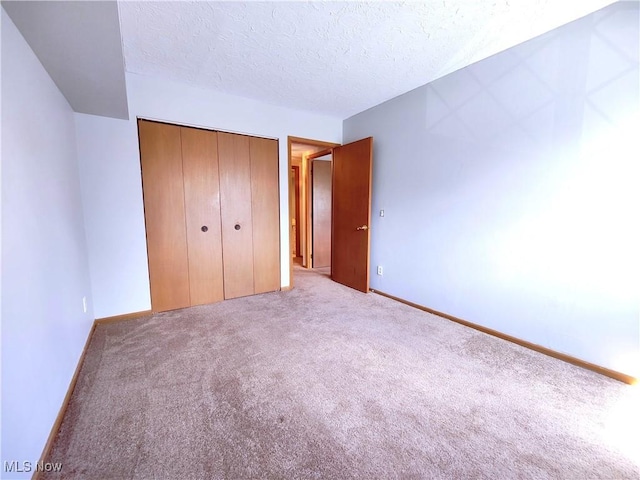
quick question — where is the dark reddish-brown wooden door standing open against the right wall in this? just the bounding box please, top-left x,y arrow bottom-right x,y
331,137 -> 373,292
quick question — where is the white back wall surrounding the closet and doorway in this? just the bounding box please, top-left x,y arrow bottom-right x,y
76,74 -> 342,318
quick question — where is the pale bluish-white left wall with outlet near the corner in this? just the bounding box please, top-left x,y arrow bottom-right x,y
0,9 -> 93,478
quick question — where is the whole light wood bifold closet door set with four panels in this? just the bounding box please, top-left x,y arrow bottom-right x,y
138,120 -> 280,312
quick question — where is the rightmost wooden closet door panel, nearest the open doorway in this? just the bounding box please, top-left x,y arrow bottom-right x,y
249,137 -> 280,293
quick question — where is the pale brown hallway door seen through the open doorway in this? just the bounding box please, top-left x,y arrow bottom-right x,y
311,160 -> 331,268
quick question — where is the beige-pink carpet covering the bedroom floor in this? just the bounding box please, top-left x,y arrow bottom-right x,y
45,270 -> 640,479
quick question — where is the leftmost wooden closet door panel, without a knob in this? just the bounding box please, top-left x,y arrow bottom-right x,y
138,120 -> 190,312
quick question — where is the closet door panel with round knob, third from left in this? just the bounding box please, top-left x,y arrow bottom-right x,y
218,132 -> 254,299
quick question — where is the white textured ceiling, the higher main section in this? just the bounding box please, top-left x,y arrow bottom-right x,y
119,0 -> 614,118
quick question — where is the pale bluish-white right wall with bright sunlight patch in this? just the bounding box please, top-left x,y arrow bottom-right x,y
344,2 -> 640,376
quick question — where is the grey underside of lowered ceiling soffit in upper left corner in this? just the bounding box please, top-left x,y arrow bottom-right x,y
2,0 -> 129,119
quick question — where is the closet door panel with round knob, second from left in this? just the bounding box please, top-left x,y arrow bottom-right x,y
180,127 -> 224,305
